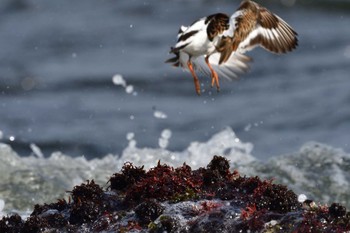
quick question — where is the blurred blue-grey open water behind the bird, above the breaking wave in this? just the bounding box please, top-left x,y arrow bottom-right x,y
0,0 -> 350,160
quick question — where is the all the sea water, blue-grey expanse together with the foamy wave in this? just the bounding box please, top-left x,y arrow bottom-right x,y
0,0 -> 350,215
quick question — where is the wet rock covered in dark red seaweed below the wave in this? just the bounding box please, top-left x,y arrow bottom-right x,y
0,156 -> 350,232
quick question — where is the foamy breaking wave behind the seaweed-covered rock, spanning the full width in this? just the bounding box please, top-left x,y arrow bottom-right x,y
0,128 -> 350,216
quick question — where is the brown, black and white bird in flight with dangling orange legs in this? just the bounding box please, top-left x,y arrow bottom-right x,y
166,0 -> 298,95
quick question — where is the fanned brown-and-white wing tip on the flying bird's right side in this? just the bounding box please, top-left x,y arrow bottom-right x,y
237,7 -> 298,53
